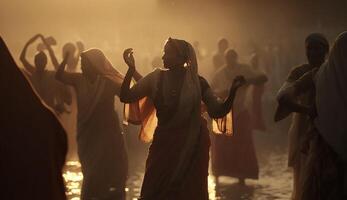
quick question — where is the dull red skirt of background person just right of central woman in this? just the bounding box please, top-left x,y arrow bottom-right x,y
211,111 -> 259,179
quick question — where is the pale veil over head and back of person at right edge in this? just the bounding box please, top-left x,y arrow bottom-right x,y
315,32 -> 347,160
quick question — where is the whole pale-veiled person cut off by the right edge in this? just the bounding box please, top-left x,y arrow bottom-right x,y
312,32 -> 347,200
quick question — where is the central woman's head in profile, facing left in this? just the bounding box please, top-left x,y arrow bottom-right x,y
162,38 -> 189,69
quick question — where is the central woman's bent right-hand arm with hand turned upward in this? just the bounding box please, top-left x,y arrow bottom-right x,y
203,76 -> 245,118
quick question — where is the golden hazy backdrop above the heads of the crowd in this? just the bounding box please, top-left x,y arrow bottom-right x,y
0,0 -> 347,76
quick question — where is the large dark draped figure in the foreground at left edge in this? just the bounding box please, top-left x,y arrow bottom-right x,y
0,38 -> 67,200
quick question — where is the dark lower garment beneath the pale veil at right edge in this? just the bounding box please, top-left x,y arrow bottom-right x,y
296,127 -> 345,200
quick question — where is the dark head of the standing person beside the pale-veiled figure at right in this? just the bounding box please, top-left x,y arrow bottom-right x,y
305,33 -> 329,67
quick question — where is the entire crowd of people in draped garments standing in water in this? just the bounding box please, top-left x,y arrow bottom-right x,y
0,32 -> 347,200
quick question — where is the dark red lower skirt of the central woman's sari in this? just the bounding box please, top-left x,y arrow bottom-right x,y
140,118 -> 210,200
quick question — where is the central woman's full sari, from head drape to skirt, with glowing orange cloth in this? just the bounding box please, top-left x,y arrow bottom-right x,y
125,39 -> 209,200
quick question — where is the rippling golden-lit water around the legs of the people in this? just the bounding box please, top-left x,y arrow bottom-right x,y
63,153 -> 293,200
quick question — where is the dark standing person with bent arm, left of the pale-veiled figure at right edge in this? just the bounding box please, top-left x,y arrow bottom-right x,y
275,33 -> 329,199
